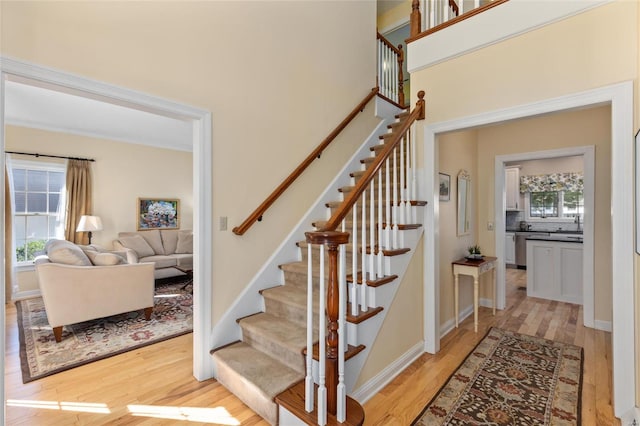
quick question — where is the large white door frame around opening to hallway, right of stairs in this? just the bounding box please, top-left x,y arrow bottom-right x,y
423,81 -> 637,417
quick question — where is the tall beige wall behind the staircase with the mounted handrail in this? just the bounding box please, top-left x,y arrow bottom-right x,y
0,1 -> 376,323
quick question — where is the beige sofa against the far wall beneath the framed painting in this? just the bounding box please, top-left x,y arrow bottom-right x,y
113,229 -> 193,279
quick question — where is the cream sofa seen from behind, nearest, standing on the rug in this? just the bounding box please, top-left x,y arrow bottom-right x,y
35,240 -> 155,342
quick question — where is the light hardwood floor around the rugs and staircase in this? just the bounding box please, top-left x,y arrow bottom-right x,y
5,270 -> 620,426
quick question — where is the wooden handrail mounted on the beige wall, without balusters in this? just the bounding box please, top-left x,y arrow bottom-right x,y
233,87 -> 378,235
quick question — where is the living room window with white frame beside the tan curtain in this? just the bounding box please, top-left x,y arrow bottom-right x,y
11,160 -> 66,265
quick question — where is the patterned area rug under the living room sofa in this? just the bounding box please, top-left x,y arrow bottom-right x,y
16,279 -> 193,383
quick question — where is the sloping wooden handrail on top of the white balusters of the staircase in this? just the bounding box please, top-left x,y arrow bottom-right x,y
321,90 -> 425,232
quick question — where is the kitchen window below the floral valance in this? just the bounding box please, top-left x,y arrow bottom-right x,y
525,191 -> 584,220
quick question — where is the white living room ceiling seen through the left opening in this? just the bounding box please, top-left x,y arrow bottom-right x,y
5,80 -> 193,151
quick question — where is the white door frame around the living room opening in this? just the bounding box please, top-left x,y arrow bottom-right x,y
0,56 -> 213,423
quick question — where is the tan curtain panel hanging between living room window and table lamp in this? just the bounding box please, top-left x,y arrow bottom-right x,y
65,160 -> 91,244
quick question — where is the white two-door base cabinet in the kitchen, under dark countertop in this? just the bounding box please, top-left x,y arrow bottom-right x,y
527,240 -> 582,305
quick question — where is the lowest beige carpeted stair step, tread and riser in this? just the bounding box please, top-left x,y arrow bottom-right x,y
212,342 -> 304,424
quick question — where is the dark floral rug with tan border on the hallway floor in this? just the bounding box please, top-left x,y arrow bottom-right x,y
412,328 -> 583,426
